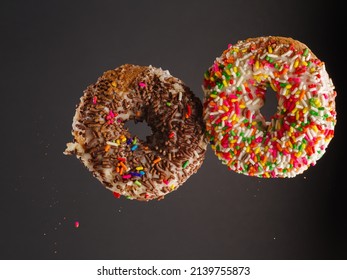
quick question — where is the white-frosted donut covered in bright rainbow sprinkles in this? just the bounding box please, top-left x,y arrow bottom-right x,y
202,36 -> 336,178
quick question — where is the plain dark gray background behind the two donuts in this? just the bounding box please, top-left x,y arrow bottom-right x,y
0,0 -> 347,259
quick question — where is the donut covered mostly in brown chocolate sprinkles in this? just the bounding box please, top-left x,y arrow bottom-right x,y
64,64 -> 207,201
